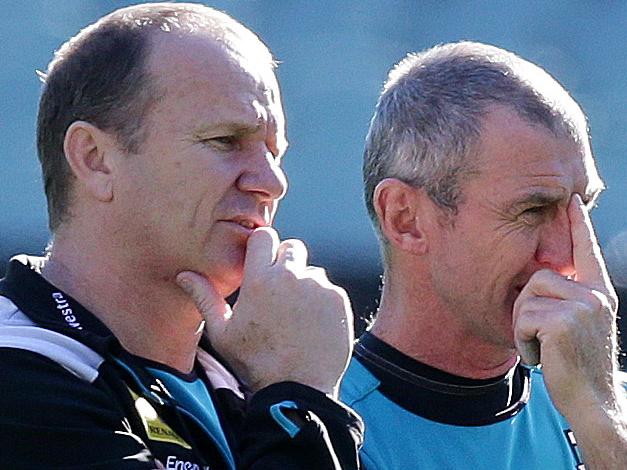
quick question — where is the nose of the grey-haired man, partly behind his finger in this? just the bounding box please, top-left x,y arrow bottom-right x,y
536,208 -> 575,276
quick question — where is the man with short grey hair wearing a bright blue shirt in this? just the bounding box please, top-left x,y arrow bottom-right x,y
341,42 -> 627,470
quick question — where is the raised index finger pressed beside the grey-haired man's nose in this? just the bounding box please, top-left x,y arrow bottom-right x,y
568,194 -> 609,287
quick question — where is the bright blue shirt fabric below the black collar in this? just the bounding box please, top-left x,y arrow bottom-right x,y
340,359 -> 578,470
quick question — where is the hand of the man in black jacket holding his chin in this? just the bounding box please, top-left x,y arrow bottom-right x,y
177,227 -> 353,395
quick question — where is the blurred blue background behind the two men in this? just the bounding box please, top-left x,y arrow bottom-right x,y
0,0 -> 627,360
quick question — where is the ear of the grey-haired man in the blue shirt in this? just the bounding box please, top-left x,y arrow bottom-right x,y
372,178 -> 428,255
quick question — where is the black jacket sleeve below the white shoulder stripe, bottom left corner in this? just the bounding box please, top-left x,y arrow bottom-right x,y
0,348 -> 156,470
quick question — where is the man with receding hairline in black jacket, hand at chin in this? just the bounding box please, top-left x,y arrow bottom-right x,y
0,3 -> 362,470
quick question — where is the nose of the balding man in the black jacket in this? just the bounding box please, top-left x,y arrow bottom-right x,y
238,150 -> 287,201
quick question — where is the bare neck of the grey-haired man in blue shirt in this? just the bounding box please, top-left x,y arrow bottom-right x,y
371,268 -> 517,379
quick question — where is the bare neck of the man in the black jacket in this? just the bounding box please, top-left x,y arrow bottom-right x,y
42,229 -> 204,373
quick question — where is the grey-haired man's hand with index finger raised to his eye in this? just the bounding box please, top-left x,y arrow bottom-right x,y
513,194 -> 618,414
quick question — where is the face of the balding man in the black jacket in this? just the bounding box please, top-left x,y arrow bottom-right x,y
116,34 -> 287,295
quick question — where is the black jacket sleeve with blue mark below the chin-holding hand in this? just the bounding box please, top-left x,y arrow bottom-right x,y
238,382 -> 363,470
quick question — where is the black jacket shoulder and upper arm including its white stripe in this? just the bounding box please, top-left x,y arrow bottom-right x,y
0,302 -> 155,469
